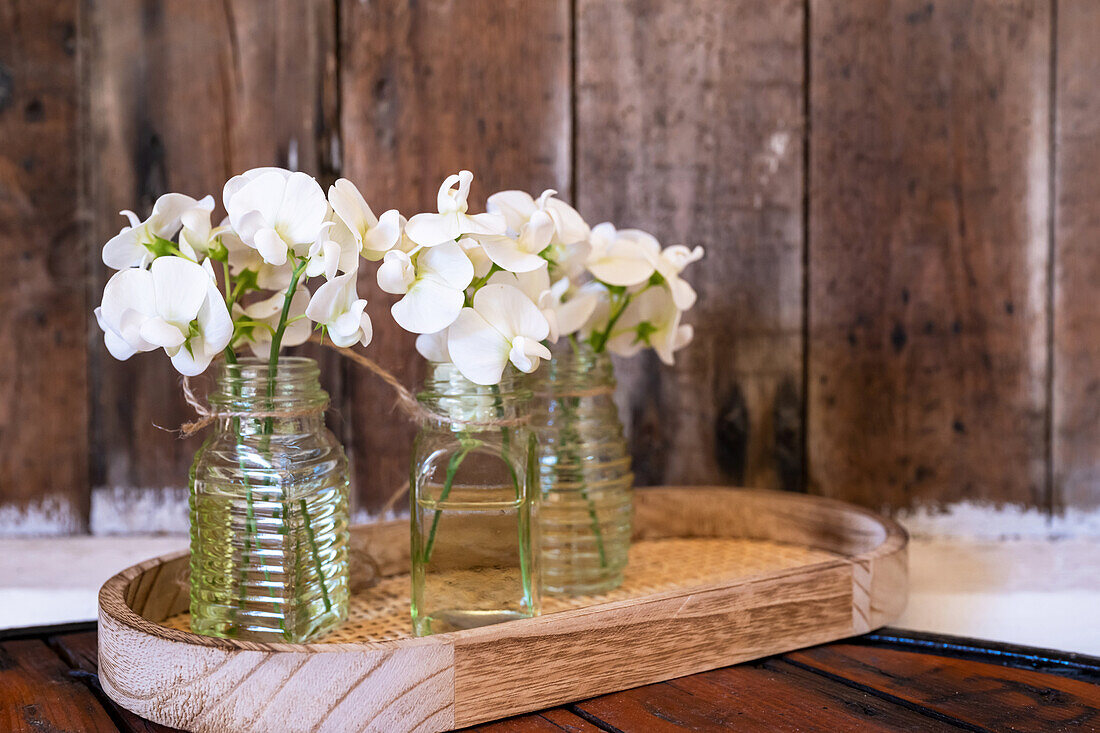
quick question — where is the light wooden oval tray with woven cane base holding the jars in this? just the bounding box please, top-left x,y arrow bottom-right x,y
99,488 -> 908,732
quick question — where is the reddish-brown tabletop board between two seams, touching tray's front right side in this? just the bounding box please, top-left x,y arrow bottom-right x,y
576,659 -> 939,733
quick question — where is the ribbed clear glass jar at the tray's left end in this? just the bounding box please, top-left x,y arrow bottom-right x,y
190,357 -> 349,643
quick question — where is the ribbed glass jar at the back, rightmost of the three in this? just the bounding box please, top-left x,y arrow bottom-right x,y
531,343 -> 634,595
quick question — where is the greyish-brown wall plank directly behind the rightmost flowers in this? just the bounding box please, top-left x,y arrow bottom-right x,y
576,0 -> 804,490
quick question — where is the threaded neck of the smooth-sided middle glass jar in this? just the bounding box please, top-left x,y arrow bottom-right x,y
417,363 -> 531,430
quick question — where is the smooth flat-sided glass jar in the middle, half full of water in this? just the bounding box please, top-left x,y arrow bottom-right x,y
409,364 -> 540,636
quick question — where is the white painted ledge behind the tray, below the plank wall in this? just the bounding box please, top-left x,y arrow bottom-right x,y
0,535 -> 1100,656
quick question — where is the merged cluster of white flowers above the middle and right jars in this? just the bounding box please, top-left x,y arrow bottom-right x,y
378,171 -> 703,384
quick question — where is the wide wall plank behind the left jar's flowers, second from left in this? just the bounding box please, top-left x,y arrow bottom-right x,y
83,0 -> 347,510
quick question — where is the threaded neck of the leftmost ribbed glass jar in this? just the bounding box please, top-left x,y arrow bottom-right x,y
209,357 -> 329,430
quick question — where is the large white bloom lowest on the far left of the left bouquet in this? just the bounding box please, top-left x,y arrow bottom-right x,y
96,256 -> 233,376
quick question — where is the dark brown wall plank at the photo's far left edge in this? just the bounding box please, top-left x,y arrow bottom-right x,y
0,0 -> 89,534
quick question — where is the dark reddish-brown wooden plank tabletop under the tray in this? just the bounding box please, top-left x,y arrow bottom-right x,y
0,623 -> 1100,733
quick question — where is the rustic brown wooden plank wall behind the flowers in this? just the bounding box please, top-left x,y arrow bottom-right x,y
0,0 -> 1100,534
